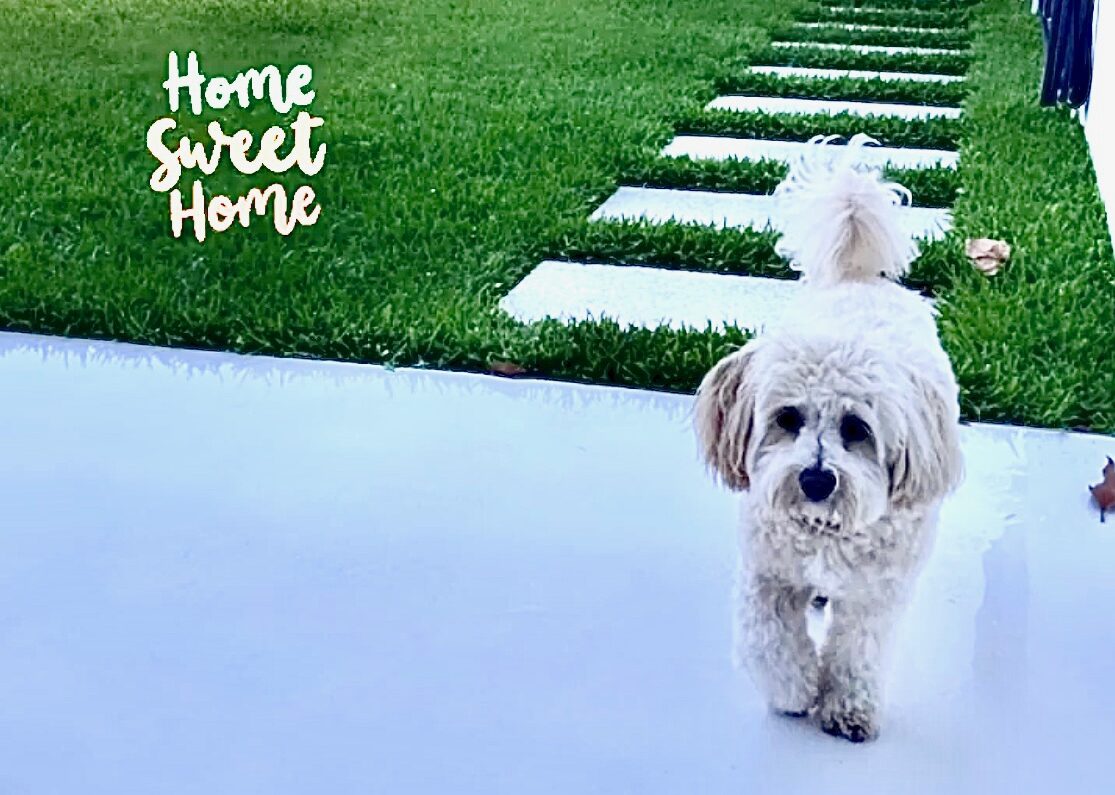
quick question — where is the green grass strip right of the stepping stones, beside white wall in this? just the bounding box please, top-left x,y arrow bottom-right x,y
940,0 -> 1115,433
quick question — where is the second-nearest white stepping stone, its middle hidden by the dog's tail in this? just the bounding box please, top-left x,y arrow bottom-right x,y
589,187 -> 951,240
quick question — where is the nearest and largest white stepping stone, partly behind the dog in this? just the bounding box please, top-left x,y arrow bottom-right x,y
500,260 -> 801,331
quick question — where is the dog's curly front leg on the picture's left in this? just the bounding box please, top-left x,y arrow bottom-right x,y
736,572 -> 820,717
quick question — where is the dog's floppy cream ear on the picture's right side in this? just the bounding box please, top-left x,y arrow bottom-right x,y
890,372 -> 963,505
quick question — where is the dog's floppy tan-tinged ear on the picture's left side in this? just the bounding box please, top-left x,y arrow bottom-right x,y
694,341 -> 756,491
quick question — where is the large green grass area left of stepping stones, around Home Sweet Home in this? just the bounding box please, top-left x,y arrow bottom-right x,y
0,0 -> 799,372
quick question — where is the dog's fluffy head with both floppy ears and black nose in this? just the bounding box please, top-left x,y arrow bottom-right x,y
696,335 -> 961,535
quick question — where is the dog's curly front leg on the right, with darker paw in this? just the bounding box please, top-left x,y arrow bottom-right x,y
818,599 -> 896,743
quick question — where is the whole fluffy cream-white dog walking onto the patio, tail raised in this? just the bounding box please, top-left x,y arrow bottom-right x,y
696,136 -> 962,743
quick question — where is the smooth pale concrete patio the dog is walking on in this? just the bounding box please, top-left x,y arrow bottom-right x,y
0,335 -> 1115,795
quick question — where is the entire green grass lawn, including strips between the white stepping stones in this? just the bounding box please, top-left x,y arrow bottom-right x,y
0,0 -> 1115,432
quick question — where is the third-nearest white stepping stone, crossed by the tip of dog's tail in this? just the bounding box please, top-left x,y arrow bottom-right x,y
662,135 -> 959,168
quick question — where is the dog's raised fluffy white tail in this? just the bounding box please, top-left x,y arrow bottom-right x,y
774,134 -> 918,284
